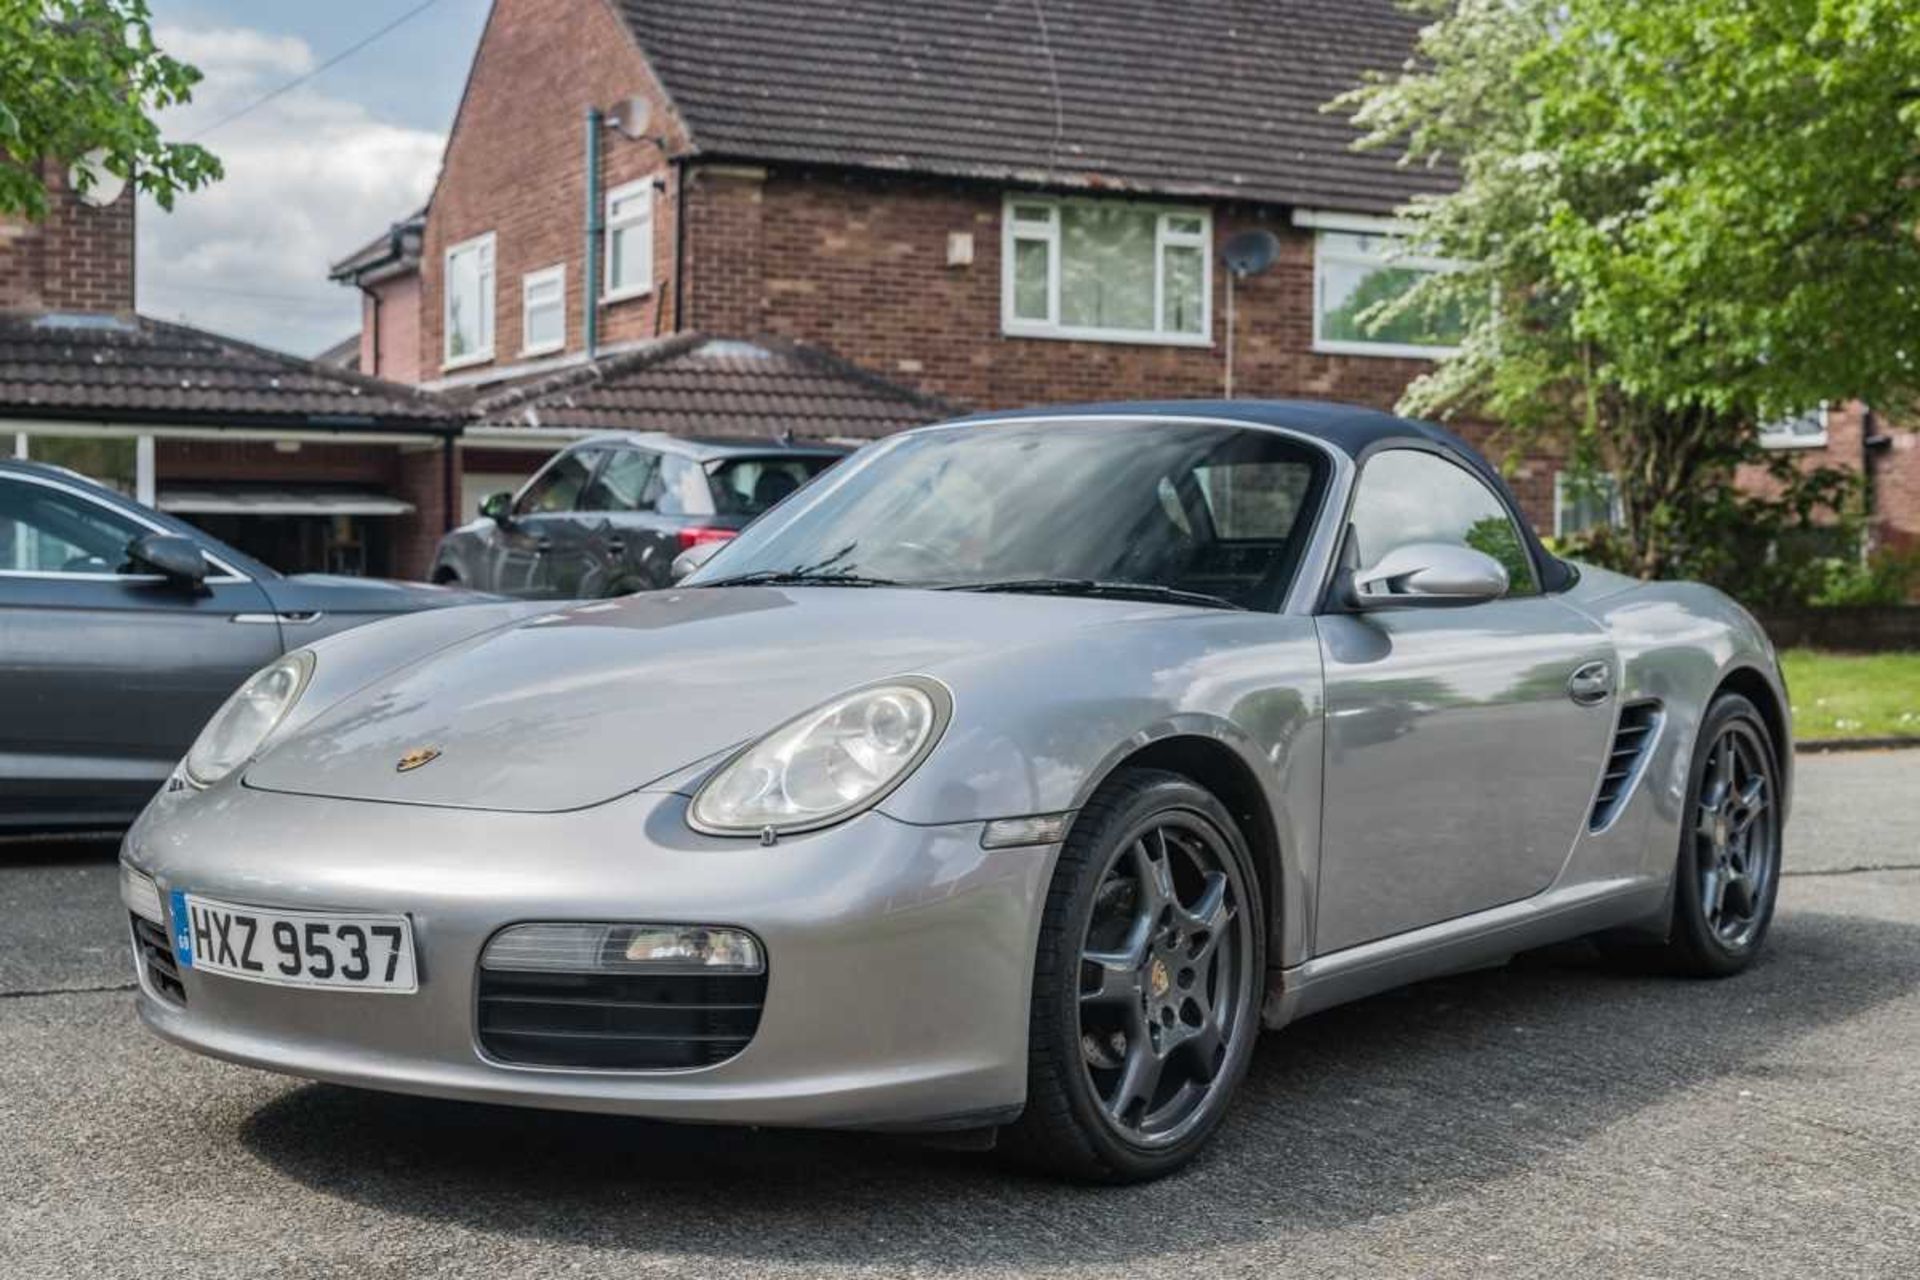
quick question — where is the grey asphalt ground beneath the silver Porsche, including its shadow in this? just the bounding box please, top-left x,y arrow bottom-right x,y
0,752 -> 1920,1280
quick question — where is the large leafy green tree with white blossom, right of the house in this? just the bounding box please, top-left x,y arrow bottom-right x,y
1331,0 -> 1920,576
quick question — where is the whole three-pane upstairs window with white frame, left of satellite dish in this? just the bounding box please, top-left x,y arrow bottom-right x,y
1000,198 -> 1213,345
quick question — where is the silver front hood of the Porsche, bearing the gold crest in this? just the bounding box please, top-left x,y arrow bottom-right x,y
246,587 -> 1192,812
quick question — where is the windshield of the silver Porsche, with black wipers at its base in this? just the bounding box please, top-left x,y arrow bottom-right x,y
687,420 -> 1323,608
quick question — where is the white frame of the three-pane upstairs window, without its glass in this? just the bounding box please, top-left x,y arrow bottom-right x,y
1000,196 -> 1213,347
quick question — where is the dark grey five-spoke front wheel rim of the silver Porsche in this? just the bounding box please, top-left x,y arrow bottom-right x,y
1079,812 -> 1256,1146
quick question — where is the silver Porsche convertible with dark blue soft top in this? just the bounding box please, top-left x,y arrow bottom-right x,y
121,401 -> 1791,1180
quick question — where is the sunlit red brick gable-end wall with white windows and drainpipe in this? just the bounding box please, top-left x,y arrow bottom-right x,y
419,0 -> 684,380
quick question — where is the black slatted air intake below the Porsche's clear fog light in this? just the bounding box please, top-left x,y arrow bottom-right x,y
478,969 -> 766,1071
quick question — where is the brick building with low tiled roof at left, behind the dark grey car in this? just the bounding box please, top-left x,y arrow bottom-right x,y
0,167 -> 463,574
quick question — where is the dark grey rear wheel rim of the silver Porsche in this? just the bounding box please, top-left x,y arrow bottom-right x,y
1693,722 -> 1780,950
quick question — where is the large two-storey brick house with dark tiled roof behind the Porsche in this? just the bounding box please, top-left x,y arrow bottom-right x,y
336,0 -> 1920,560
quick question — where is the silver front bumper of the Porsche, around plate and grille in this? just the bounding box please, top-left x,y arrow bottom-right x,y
123,783 -> 1056,1126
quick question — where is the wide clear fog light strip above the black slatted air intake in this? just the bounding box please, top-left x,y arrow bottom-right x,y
480,923 -> 766,973
